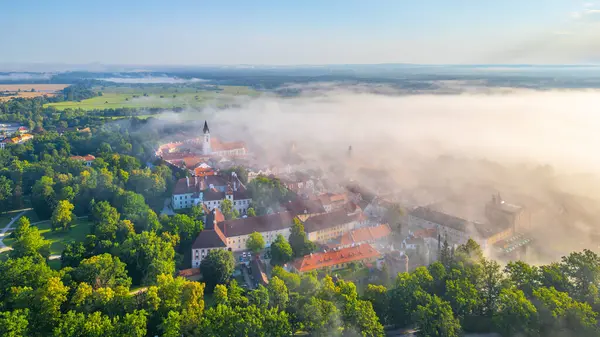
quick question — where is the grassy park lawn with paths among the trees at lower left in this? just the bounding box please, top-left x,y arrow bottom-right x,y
4,218 -> 91,255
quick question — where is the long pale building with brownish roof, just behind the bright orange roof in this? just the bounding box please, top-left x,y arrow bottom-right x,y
304,207 -> 366,243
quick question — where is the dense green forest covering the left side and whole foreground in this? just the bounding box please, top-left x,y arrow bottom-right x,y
0,86 -> 600,337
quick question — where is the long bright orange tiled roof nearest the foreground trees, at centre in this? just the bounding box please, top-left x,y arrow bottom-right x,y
293,243 -> 381,272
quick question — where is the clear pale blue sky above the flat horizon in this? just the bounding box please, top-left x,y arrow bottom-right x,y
0,0 -> 600,65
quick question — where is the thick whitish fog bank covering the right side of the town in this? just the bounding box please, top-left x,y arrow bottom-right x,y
149,87 -> 600,262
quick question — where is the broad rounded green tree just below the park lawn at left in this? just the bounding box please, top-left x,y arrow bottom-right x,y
73,254 -> 131,288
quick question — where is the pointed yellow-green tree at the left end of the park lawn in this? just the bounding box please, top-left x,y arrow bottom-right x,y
10,217 -> 50,258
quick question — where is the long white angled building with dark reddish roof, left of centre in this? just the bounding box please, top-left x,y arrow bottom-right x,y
192,209 -> 294,268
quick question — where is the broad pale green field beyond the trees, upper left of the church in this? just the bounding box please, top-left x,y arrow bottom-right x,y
44,86 -> 258,110
